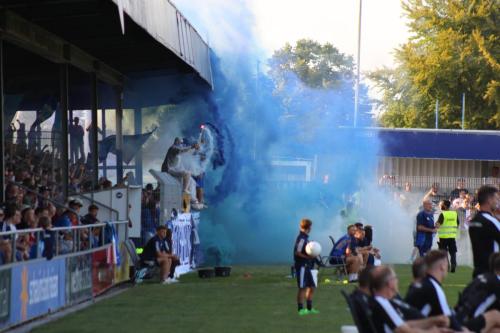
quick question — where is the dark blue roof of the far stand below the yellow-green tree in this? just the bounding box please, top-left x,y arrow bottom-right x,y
376,128 -> 500,161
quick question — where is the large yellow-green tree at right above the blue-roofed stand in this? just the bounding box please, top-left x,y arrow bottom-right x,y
369,0 -> 500,129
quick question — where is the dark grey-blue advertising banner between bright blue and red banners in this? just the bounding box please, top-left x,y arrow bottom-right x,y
66,254 -> 92,304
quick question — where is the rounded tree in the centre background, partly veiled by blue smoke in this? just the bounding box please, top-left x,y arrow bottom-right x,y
268,39 -> 372,136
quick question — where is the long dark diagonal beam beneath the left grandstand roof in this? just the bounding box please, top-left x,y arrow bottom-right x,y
0,9 -> 123,86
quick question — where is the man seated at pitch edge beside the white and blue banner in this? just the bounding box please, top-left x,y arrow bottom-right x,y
141,225 -> 178,284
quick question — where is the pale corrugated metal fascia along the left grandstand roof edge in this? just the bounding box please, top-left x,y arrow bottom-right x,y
112,0 -> 213,86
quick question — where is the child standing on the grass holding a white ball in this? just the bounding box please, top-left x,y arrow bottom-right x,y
293,219 -> 321,316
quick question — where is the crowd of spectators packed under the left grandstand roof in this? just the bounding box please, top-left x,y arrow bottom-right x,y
0,117 -> 119,264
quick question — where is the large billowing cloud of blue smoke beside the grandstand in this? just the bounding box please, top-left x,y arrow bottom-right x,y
139,0 -> 410,264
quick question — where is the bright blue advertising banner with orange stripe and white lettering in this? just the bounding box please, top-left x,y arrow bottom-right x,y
10,258 -> 66,323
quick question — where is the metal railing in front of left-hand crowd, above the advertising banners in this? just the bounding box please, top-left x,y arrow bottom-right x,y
0,221 -> 129,268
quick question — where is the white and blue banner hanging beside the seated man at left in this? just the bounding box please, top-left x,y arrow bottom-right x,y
172,213 -> 192,265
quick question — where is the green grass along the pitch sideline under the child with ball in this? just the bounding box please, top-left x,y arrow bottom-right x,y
32,265 -> 472,333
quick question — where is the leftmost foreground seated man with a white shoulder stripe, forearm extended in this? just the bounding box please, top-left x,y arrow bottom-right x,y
370,266 -> 449,333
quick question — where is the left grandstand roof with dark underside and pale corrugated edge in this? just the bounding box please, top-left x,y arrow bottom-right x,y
0,0 -> 212,109
